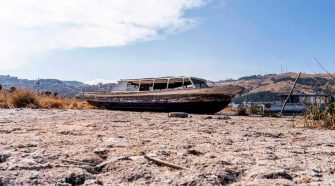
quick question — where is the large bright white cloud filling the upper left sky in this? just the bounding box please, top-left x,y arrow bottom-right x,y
0,0 -> 207,70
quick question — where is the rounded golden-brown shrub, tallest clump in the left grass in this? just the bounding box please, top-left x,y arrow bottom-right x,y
10,90 -> 40,108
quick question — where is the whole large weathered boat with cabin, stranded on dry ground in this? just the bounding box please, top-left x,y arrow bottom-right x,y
84,77 -> 243,114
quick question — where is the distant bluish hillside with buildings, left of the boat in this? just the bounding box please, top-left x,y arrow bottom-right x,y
0,75 -> 115,98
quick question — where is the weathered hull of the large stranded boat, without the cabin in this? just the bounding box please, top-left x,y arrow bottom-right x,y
86,86 -> 243,114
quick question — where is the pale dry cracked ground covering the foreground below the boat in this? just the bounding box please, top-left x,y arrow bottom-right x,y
0,109 -> 335,186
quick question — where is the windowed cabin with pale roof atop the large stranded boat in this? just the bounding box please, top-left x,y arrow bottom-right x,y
113,76 -> 208,92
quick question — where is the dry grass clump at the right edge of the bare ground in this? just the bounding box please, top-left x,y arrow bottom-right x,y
304,103 -> 335,129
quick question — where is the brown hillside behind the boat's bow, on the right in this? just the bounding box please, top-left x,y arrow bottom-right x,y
215,73 -> 335,102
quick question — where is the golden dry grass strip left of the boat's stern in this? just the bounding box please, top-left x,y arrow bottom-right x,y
0,89 -> 93,109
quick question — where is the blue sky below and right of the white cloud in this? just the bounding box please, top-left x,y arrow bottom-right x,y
0,0 -> 335,82
